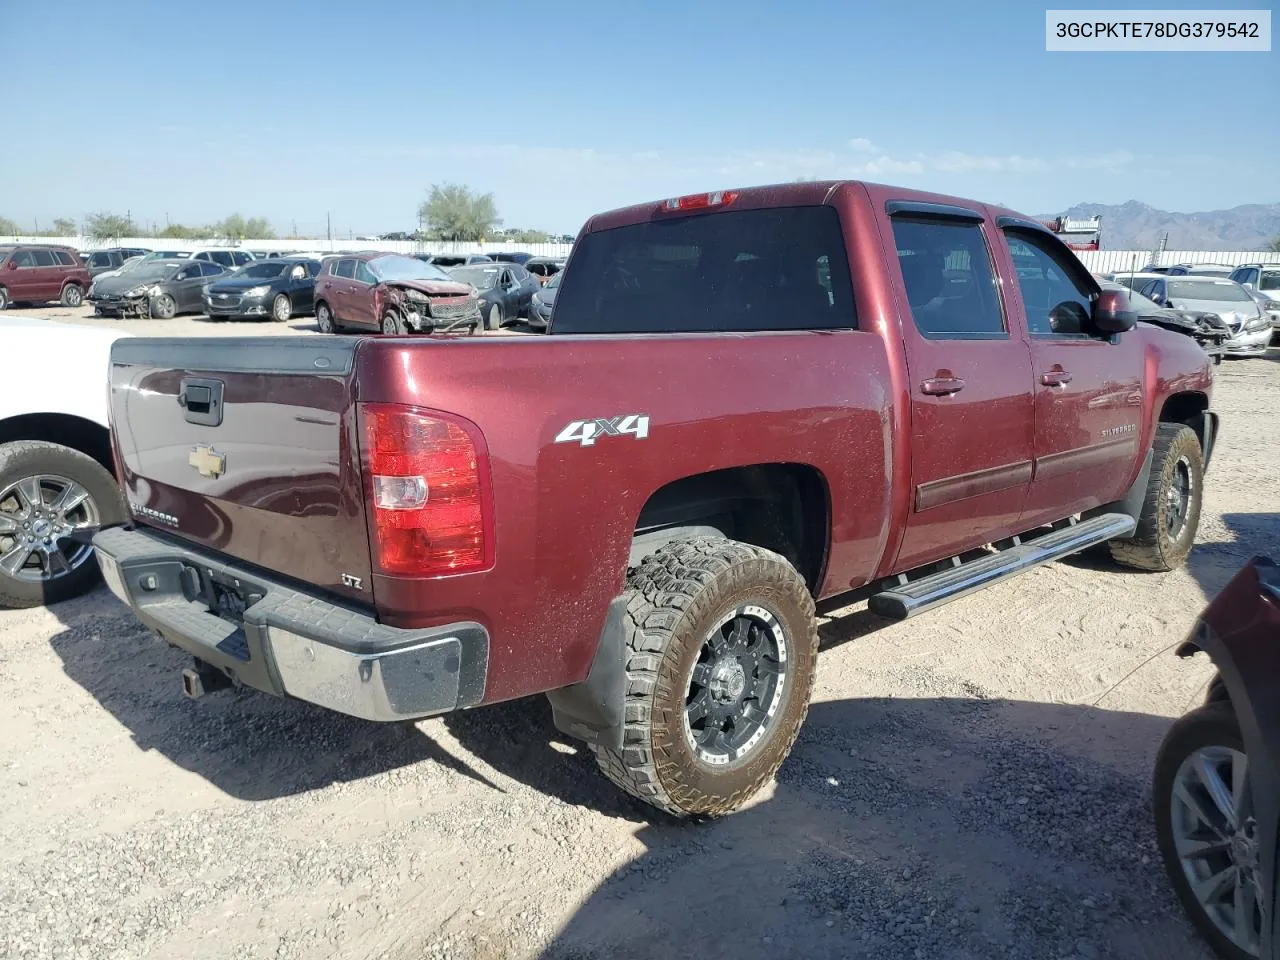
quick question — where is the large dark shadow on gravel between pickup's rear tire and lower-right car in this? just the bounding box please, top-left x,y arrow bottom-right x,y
519,699 -> 1208,960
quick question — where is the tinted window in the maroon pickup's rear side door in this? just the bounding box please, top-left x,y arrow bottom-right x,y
893,216 -> 1007,339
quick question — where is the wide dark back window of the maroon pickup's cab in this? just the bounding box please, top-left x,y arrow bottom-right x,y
552,206 -> 858,334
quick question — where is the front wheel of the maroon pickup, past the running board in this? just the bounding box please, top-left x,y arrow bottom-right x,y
1110,424 -> 1204,571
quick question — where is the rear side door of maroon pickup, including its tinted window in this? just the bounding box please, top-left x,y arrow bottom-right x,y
890,201 -> 1032,570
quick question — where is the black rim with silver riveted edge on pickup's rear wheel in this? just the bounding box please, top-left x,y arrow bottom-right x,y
685,604 -> 790,767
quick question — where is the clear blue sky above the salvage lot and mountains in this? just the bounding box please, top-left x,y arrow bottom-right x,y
0,0 -> 1280,236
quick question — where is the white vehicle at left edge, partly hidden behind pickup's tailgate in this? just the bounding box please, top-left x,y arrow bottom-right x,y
0,316 -> 127,607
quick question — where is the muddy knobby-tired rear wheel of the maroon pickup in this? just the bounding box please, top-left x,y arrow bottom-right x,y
594,536 -> 818,817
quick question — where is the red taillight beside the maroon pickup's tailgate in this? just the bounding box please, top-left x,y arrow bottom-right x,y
360,403 -> 493,576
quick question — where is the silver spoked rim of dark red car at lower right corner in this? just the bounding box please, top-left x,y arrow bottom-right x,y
1170,746 -> 1262,956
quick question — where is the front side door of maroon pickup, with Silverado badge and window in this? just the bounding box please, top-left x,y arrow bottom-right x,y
1004,227 -> 1143,527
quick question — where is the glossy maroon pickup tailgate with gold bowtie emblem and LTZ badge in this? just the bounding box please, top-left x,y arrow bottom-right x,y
110,337 -> 371,603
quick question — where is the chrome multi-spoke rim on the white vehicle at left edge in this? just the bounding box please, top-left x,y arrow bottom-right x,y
0,474 -> 99,584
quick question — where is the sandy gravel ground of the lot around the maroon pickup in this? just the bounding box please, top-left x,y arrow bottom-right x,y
0,310 -> 1280,960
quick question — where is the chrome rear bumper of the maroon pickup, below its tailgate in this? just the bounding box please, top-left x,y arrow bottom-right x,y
93,527 -> 489,721
